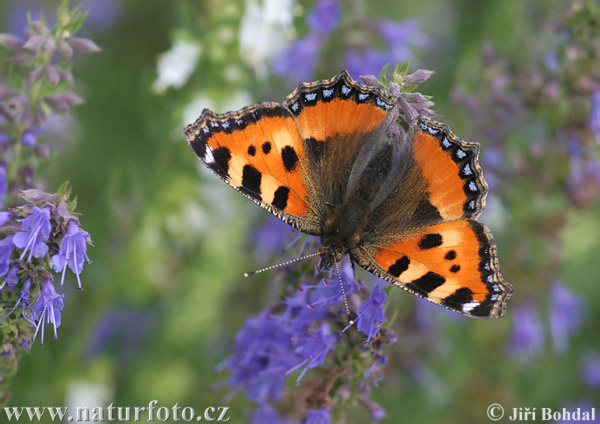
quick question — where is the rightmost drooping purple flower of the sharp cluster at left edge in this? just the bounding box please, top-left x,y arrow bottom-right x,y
52,219 -> 90,288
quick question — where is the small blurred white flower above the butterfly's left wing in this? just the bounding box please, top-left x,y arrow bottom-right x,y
152,40 -> 201,93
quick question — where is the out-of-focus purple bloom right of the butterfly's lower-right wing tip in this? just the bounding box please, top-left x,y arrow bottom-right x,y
549,283 -> 583,353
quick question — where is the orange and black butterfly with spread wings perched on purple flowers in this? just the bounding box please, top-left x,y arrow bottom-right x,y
185,71 -> 513,318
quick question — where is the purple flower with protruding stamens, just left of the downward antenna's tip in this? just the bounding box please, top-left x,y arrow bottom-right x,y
285,324 -> 339,382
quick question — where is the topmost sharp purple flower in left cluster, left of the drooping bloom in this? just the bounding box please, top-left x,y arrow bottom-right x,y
13,206 -> 52,262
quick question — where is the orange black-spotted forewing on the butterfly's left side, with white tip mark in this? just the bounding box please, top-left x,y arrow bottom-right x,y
185,103 -> 320,234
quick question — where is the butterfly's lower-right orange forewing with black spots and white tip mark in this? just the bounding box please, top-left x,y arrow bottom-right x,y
350,220 -> 513,318
